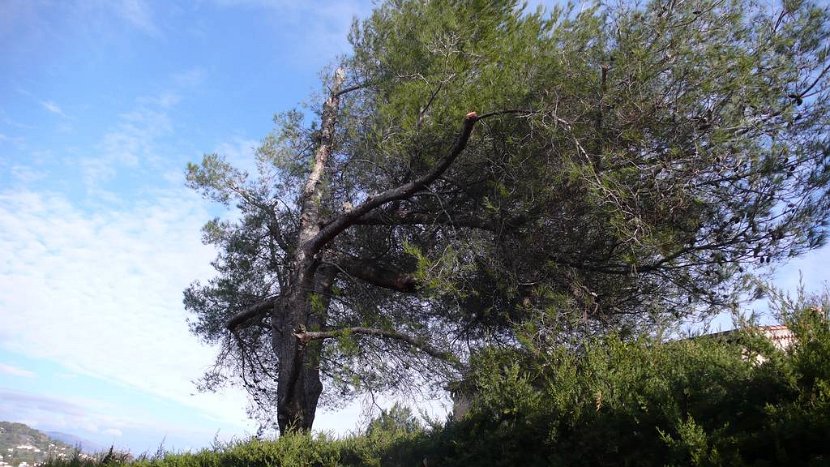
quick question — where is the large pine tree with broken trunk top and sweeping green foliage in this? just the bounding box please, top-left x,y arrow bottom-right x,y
185,0 -> 830,432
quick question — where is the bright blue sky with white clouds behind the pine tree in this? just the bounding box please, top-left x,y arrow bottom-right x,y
0,0 -> 830,458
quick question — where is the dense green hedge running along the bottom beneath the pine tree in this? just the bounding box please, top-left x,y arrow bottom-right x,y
45,307 -> 830,467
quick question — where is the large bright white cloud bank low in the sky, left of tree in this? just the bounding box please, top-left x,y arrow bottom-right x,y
0,190 -> 250,423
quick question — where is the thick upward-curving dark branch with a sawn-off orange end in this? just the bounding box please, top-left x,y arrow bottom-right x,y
303,112 -> 479,254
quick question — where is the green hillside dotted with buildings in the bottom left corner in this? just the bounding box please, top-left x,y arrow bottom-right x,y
0,422 -> 87,467
